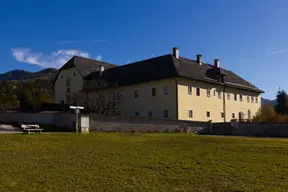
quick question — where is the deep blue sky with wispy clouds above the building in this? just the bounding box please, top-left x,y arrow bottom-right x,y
0,0 -> 288,99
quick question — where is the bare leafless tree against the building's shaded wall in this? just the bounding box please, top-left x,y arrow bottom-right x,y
79,79 -> 123,114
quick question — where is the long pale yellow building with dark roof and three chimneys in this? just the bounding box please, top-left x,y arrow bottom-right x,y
54,48 -> 263,122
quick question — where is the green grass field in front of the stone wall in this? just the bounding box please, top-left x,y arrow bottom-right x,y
0,133 -> 288,192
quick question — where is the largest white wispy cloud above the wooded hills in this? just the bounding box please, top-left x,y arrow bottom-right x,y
11,48 -> 102,68
